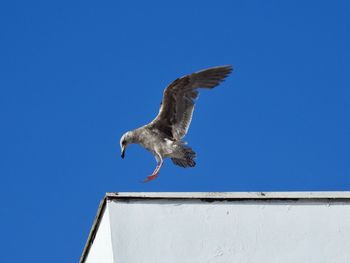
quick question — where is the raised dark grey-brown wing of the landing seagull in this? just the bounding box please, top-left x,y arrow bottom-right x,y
149,65 -> 232,140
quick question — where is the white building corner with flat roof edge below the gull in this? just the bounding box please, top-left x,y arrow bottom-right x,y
80,192 -> 350,263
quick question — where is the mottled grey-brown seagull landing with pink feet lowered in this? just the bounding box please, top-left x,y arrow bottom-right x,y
120,65 -> 232,182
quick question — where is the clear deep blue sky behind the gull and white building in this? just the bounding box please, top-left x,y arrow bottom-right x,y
0,0 -> 350,263
